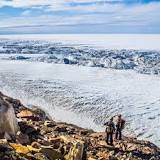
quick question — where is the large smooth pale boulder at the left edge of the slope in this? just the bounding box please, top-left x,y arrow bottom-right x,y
0,96 -> 19,138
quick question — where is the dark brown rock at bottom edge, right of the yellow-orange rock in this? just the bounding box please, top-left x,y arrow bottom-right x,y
40,146 -> 62,160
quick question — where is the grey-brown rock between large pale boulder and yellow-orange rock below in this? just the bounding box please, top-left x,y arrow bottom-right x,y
16,131 -> 30,144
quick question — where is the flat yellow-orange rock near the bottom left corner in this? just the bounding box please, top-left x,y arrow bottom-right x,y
9,143 -> 30,155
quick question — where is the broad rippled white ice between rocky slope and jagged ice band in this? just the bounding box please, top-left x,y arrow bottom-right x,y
0,60 -> 160,145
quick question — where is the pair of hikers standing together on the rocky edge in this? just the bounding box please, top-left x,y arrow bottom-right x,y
104,114 -> 125,145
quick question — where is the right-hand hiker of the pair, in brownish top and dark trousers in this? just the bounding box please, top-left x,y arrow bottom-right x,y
115,114 -> 125,140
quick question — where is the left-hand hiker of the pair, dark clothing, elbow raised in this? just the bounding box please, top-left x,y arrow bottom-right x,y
104,118 -> 115,145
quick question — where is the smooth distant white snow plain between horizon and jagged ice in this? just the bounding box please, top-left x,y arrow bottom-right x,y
0,34 -> 160,50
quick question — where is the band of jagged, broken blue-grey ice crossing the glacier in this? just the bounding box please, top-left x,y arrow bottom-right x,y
0,40 -> 160,75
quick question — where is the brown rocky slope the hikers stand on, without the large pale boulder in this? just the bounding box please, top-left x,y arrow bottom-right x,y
0,93 -> 160,160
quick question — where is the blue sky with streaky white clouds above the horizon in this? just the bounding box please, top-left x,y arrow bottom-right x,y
0,0 -> 160,34
